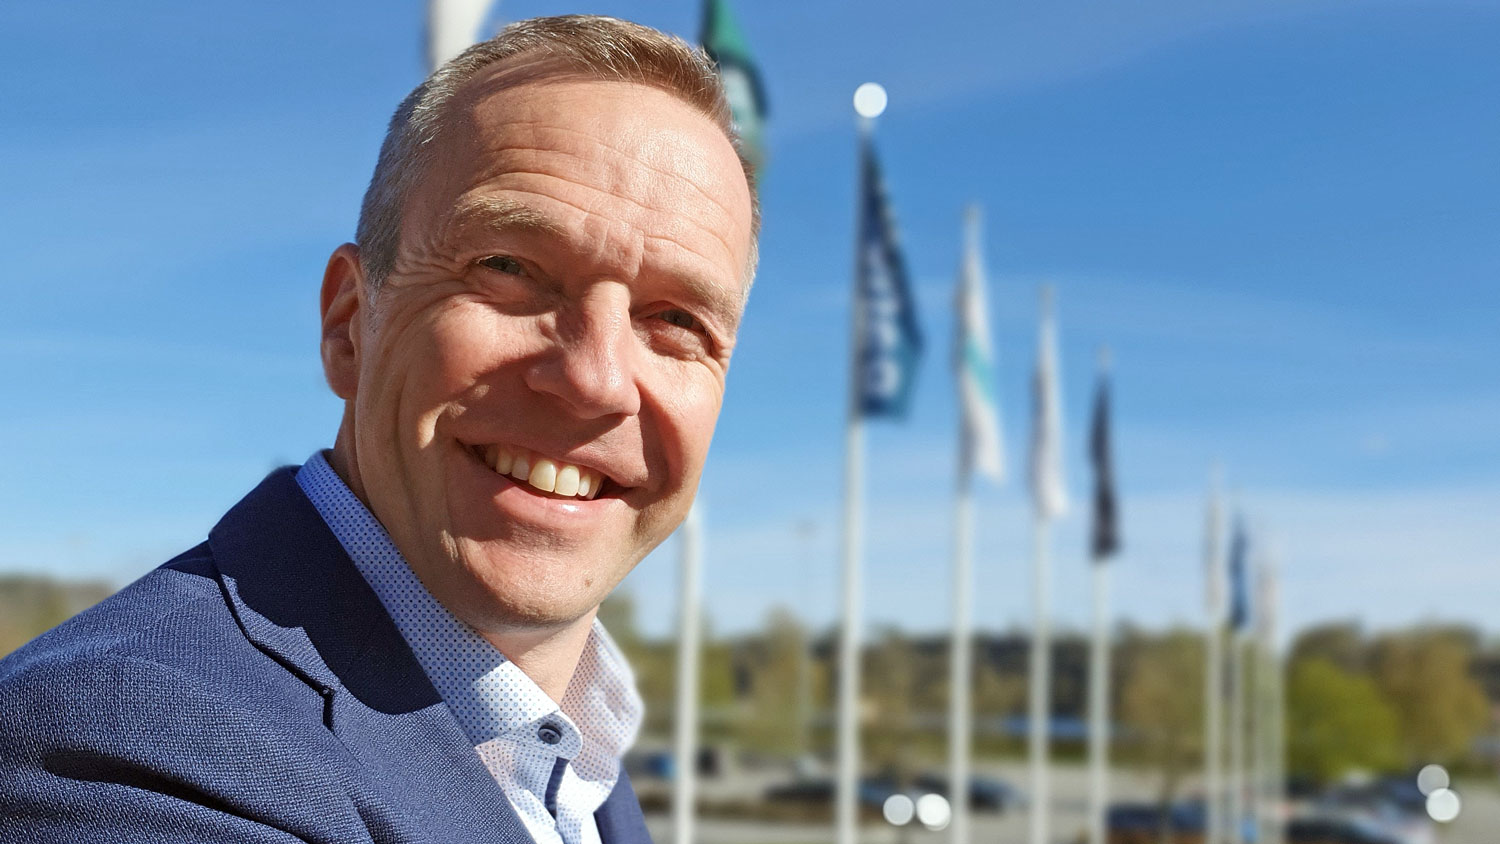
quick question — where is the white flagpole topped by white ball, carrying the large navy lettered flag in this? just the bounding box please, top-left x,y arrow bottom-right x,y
834,103 -> 879,844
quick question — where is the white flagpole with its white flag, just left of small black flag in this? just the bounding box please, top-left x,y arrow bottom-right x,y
1028,286 -> 1067,844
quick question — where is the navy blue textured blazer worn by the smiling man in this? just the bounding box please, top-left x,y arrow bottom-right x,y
0,468 -> 651,844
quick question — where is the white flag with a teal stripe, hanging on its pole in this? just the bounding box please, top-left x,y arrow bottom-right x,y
954,205 -> 1005,483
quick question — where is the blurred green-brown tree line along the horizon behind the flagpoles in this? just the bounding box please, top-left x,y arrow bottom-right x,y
0,576 -> 1500,799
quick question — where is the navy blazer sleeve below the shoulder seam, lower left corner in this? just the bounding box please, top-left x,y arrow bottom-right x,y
0,651 -> 365,841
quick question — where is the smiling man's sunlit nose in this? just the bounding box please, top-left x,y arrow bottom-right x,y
527,285 -> 641,418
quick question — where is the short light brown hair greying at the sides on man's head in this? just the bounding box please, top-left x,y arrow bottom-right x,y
354,15 -> 761,291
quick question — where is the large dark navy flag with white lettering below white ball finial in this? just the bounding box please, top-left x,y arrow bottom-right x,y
854,138 -> 923,418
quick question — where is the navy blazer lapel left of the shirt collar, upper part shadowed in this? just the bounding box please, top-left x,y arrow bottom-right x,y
209,468 -> 540,844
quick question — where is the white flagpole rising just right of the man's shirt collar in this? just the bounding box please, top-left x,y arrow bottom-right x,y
672,502 -> 704,844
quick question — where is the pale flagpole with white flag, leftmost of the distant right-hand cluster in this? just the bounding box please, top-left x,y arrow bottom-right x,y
1203,468 -> 1224,844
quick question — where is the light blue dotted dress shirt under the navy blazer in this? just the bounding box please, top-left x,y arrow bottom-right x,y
297,451 -> 644,844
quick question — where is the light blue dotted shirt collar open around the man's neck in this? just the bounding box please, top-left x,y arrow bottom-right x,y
297,451 -> 644,774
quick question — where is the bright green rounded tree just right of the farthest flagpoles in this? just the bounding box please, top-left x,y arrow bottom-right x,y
1287,657 -> 1398,783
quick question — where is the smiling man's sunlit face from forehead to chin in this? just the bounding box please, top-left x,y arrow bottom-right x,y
326,73 -> 752,633
